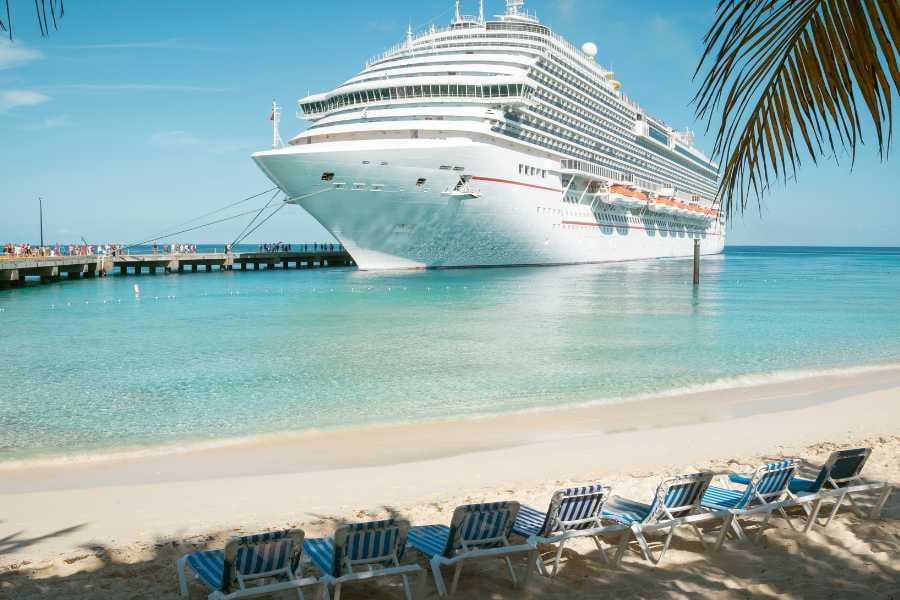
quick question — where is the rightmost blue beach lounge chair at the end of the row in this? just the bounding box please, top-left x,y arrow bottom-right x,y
731,448 -> 892,532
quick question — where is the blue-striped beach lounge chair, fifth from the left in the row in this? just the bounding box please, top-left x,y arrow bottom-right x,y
600,473 -> 731,564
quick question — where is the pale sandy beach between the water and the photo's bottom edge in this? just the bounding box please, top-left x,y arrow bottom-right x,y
0,367 -> 900,599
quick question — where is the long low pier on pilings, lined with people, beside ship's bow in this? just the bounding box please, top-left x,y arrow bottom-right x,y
0,250 -> 356,287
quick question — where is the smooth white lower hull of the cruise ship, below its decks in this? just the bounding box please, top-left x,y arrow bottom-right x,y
254,138 -> 725,270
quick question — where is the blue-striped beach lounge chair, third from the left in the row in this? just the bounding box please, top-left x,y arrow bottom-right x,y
409,502 -> 534,597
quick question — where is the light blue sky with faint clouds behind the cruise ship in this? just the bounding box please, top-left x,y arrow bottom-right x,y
0,0 -> 900,245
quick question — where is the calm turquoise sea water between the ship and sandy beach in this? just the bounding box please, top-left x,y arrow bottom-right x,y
0,248 -> 900,461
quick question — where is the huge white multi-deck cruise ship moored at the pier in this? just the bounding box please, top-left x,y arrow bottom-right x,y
253,0 -> 725,270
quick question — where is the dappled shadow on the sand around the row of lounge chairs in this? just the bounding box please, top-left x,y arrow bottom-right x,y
0,476 -> 900,600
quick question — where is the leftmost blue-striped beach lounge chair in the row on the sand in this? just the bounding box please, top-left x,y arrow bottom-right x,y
177,529 -> 319,600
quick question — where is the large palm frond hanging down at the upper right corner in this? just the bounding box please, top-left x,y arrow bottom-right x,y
693,0 -> 900,216
